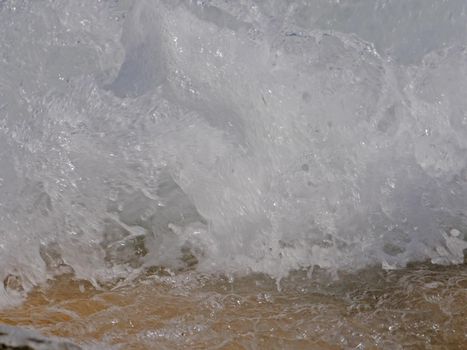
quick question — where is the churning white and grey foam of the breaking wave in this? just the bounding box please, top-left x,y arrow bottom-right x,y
0,0 -> 467,305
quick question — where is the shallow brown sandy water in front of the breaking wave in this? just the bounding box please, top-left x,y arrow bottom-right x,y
0,264 -> 467,349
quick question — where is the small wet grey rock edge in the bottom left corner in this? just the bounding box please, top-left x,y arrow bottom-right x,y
0,325 -> 81,350
